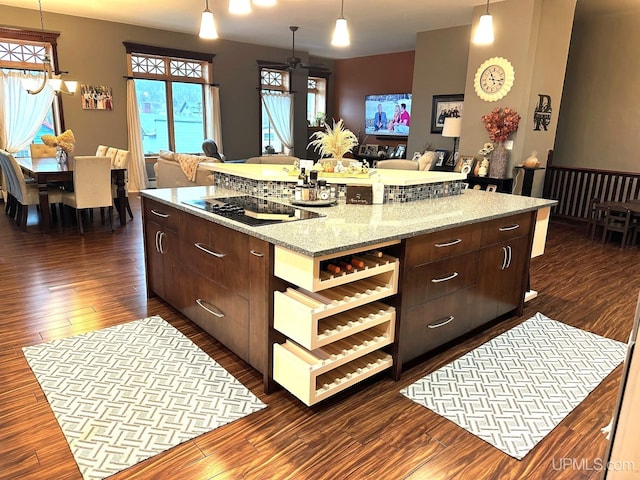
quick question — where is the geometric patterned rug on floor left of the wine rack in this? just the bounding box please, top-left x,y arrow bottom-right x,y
23,316 -> 266,480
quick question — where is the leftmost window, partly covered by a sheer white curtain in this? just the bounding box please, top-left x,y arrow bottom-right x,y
0,28 -> 64,157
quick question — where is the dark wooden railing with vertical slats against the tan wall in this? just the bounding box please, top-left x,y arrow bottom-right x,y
542,166 -> 640,221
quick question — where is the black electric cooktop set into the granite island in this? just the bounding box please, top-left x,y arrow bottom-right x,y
183,195 -> 324,227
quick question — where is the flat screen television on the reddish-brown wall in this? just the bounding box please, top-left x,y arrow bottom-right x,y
364,93 -> 411,137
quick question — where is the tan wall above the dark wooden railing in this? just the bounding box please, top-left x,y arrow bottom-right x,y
553,7 -> 640,173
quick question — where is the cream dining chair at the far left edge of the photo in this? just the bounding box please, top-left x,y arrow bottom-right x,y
0,150 -> 62,230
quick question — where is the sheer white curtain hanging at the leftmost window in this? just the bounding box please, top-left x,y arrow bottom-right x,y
0,71 -> 54,153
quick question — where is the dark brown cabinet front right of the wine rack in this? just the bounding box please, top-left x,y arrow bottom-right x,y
394,212 -> 535,376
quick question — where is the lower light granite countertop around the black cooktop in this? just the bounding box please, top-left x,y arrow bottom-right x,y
140,187 -> 557,257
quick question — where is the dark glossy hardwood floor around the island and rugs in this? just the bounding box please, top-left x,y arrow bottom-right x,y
0,196 -> 640,480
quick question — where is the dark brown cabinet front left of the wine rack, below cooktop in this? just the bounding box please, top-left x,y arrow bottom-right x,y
143,198 -> 272,376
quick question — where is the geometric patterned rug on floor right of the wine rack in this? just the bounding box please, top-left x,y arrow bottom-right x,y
400,313 -> 627,460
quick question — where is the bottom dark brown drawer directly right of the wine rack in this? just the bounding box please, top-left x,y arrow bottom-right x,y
400,287 -> 475,362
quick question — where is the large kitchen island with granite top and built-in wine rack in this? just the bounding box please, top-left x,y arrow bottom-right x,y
141,187 -> 555,405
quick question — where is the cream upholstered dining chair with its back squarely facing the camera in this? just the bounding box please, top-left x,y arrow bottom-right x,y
62,156 -> 113,235
